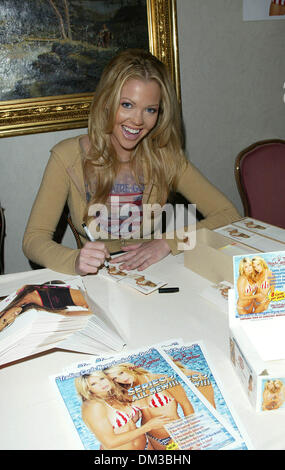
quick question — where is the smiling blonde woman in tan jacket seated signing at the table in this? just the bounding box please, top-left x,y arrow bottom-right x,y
23,49 -> 240,275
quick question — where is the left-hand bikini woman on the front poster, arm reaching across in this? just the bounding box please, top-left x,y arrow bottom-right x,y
75,371 -> 168,450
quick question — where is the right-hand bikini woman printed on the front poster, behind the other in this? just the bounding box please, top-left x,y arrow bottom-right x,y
105,363 -> 194,450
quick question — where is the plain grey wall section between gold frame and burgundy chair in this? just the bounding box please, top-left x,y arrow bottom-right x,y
177,0 -> 285,207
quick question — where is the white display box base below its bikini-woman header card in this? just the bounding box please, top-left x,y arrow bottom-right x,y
229,289 -> 285,412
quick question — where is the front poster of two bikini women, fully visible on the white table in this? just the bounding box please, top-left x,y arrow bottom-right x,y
49,347 -> 240,451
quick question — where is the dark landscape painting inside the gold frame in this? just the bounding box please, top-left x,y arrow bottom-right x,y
0,0 -> 149,101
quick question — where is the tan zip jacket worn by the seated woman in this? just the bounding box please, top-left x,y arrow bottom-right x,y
23,136 -> 240,274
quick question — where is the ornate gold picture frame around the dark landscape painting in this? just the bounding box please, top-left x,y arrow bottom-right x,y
0,0 -> 180,137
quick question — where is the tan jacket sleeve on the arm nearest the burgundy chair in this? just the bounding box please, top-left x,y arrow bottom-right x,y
166,162 -> 241,254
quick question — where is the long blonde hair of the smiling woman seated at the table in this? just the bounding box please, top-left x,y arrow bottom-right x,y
83,49 -> 185,204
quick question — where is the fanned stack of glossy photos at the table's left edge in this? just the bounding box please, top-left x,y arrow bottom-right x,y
0,277 -> 125,365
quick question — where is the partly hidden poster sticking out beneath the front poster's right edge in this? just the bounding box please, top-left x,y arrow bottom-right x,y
163,342 -> 252,450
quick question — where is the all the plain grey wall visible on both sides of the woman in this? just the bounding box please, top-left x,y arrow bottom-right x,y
0,0 -> 285,273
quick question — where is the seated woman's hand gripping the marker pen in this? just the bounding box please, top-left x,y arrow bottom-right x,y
75,242 -> 110,276
